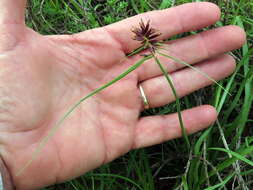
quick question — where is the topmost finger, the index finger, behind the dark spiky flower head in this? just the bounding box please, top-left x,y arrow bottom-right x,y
104,2 -> 220,53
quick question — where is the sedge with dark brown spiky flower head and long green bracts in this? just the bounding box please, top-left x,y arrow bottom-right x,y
16,20 -> 229,176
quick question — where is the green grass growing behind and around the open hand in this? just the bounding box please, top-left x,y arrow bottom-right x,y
26,0 -> 253,190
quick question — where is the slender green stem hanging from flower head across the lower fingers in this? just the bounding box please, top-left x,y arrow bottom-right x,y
152,52 -> 191,150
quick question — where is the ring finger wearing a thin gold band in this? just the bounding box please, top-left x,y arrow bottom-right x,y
140,55 -> 235,108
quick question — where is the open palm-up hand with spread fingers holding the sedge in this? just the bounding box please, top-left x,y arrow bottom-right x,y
0,0 -> 245,190
